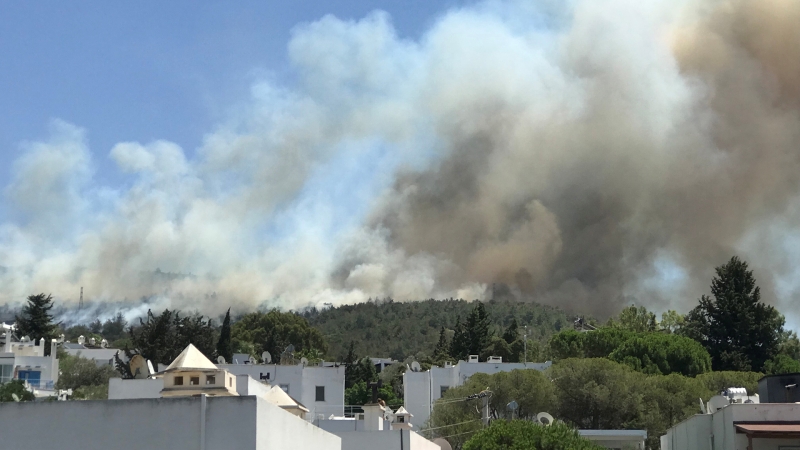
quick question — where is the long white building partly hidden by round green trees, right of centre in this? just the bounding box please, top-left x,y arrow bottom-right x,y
403,355 -> 552,424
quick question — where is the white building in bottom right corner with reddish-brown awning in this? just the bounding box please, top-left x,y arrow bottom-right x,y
661,403 -> 800,450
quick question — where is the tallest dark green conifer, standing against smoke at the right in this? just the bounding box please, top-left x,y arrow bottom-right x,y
681,256 -> 784,371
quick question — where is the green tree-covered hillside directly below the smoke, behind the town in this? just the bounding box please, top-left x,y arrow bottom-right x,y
302,299 -> 572,360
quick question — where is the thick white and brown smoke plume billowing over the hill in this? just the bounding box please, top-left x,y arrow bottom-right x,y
0,0 -> 800,315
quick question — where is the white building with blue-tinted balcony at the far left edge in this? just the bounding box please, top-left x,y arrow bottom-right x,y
0,333 -> 58,396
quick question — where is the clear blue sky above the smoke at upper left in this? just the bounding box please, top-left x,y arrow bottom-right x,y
0,0 -> 472,190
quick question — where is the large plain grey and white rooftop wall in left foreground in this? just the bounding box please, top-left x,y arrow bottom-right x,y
0,397 -> 340,450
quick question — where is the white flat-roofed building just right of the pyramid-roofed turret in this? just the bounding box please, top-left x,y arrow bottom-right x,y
217,358 -> 344,417
